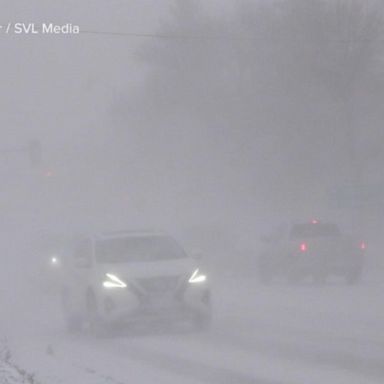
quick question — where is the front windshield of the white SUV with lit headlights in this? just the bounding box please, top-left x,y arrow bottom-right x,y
96,236 -> 186,263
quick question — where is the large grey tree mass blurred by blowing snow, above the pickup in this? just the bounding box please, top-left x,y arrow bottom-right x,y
114,0 -> 384,220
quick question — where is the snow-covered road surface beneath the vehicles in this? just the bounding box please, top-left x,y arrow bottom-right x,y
1,277 -> 384,384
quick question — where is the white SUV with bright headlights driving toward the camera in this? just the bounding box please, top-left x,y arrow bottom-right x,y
62,232 -> 211,331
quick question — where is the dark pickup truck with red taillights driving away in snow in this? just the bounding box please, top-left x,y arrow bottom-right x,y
258,220 -> 366,284
